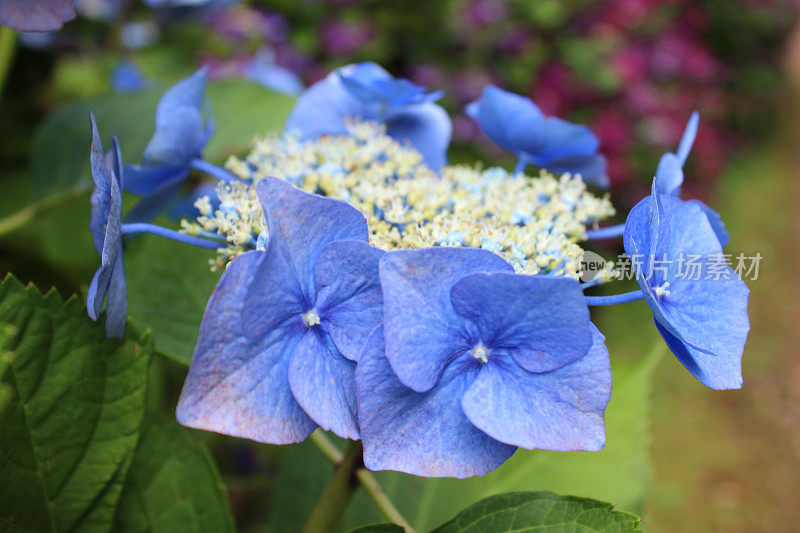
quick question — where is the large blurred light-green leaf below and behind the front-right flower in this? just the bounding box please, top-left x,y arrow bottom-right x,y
270,345 -> 664,531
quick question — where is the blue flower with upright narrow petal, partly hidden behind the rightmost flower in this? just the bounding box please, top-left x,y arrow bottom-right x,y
656,111 -> 730,247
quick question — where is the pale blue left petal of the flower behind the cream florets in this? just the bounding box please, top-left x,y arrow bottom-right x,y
284,71 -> 368,139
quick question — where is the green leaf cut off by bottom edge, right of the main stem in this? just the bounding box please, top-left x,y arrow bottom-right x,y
352,492 -> 641,533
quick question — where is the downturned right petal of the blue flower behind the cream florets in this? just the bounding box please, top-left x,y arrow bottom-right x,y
386,103 -> 453,171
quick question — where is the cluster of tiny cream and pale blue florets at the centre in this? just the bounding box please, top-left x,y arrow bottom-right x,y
183,122 -> 614,280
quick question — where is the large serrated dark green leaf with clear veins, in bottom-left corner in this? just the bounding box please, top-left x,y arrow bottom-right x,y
0,275 -> 152,531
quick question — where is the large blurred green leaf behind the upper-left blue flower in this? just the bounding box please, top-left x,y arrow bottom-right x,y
31,80 -> 293,198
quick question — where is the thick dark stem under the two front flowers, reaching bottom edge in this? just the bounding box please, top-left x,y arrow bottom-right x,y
303,442 -> 362,533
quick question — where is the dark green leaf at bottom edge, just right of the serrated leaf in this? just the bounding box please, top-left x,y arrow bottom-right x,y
113,413 -> 233,533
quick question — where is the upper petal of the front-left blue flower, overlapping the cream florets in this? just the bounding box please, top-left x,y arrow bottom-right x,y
242,177 -> 369,338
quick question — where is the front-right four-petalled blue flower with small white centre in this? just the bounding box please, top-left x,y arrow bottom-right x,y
356,247 -> 611,478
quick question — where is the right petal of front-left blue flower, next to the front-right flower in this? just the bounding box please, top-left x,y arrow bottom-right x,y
314,241 -> 386,361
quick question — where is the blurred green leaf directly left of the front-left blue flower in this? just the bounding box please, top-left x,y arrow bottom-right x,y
125,235 -> 220,365
